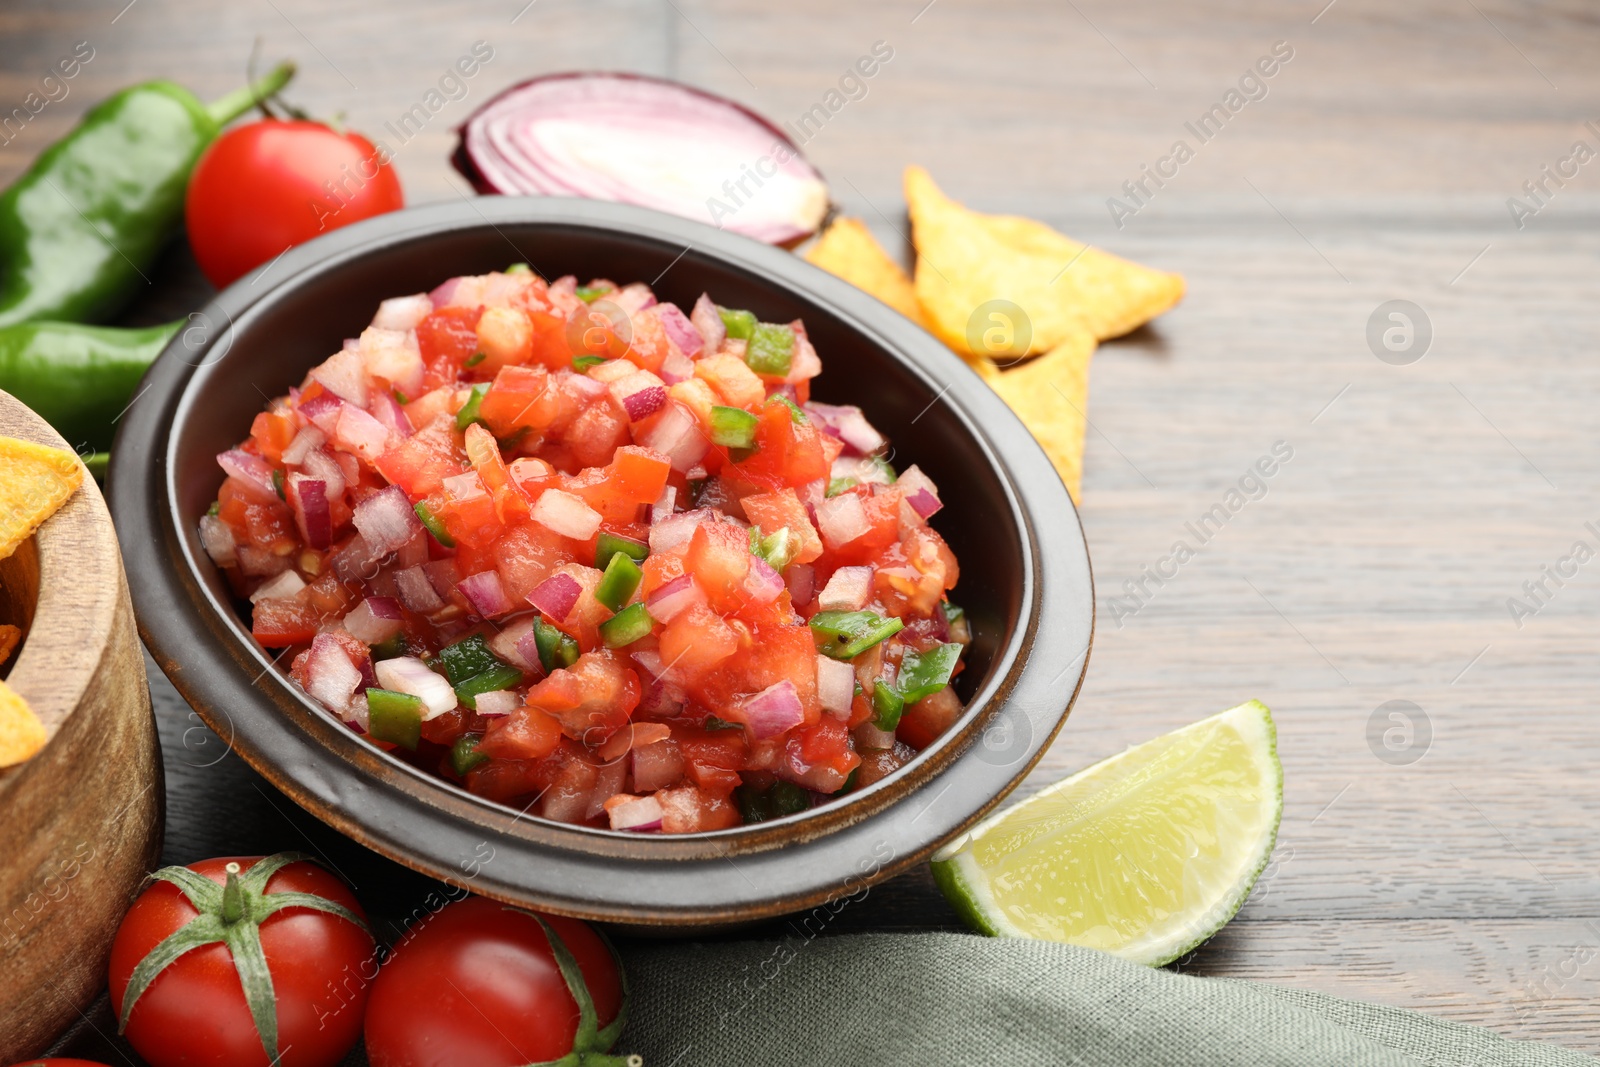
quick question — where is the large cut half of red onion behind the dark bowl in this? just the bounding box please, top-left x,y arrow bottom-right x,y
454,74 -> 827,245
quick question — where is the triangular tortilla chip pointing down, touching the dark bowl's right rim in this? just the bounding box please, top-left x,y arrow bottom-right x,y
978,334 -> 1094,504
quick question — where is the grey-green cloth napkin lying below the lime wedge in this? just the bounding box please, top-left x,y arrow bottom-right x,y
618,934 -> 1595,1067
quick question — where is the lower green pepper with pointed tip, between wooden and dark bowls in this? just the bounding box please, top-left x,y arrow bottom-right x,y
0,316 -> 186,451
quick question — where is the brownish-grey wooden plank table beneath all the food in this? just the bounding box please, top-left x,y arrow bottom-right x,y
0,0 -> 1600,1051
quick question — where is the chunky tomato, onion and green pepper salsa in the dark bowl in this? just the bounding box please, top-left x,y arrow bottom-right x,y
200,266 -> 970,833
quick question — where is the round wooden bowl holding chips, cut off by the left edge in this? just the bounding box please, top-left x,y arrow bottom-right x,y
0,392 -> 166,1064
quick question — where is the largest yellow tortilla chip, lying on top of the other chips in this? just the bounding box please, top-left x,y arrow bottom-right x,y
906,166 -> 1184,357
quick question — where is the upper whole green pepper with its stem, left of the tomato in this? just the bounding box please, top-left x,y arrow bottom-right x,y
0,64 -> 294,326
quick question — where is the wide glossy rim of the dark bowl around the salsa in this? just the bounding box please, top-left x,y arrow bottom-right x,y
110,197 -> 1094,923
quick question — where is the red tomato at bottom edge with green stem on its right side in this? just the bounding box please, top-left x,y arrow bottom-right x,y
366,897 -> 630,1067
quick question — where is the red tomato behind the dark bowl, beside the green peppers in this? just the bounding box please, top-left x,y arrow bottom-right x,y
184,118 -> 405,288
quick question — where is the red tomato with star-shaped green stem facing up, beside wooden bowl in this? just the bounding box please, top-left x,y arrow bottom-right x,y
110,854 -> 376,1067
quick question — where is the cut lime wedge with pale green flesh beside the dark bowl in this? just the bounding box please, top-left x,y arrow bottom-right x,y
933,701 -> 1283,966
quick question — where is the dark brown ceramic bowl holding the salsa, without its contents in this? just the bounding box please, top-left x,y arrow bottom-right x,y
110,197 -> 1094,925
